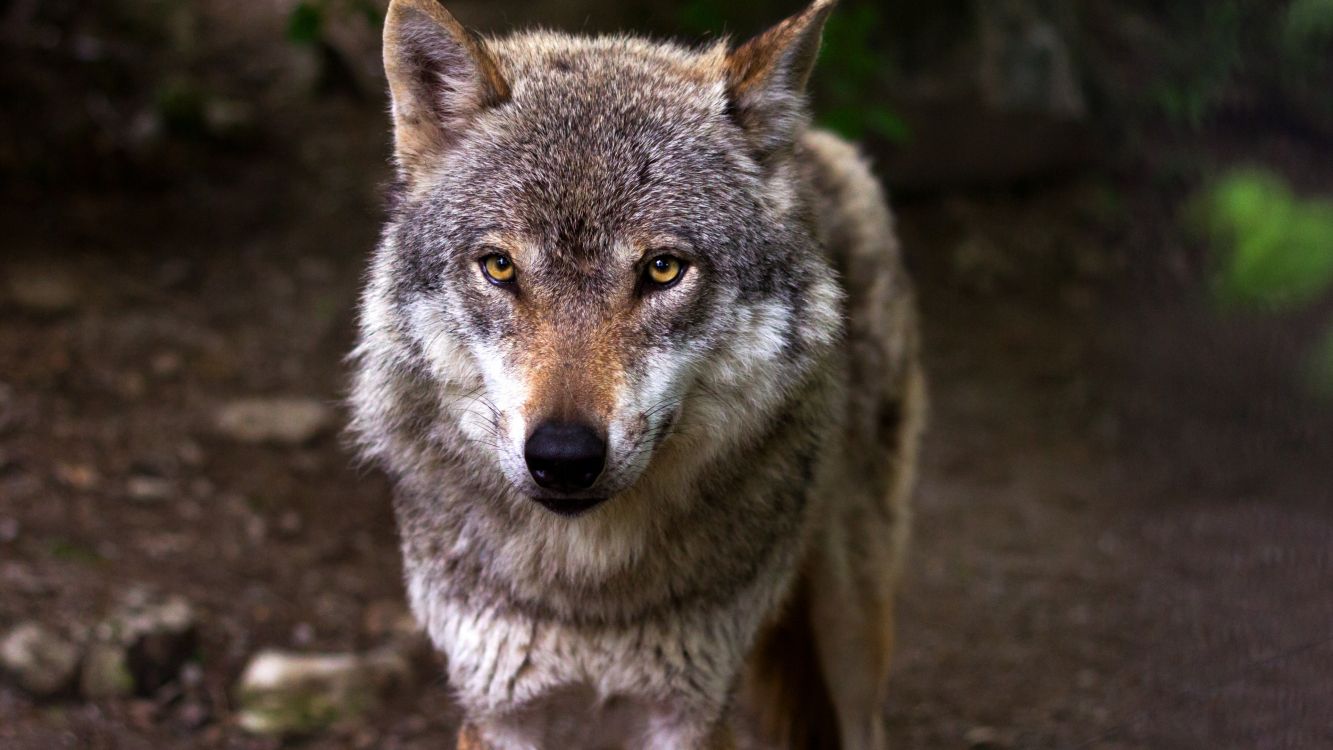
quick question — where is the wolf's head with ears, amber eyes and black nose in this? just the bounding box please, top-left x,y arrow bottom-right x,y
353,0 -> 841,514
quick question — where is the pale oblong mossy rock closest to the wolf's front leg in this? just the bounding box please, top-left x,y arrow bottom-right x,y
236,649 -> 412,737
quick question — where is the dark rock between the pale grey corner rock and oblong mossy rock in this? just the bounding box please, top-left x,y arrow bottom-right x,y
84,591 -> 197,695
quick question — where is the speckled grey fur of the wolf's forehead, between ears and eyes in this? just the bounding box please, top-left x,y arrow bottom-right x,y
405,32 -> 764,260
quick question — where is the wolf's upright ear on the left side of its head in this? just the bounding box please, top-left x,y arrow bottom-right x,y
384,0 -> 509,180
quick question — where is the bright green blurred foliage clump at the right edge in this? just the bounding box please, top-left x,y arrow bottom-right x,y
1201,171 -> 1333,309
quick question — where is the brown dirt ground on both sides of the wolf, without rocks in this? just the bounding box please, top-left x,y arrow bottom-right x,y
0,2 -> 1333,750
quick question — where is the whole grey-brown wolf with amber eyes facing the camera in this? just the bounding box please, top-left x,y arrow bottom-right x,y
351,0 -> 925,750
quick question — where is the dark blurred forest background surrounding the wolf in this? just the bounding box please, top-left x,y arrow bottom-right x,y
0,0 -> 1333,750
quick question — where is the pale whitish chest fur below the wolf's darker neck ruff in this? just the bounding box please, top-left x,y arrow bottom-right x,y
409,556 -> 789,729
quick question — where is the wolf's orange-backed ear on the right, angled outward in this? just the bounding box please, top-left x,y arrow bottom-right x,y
726,0 -> 836,155
